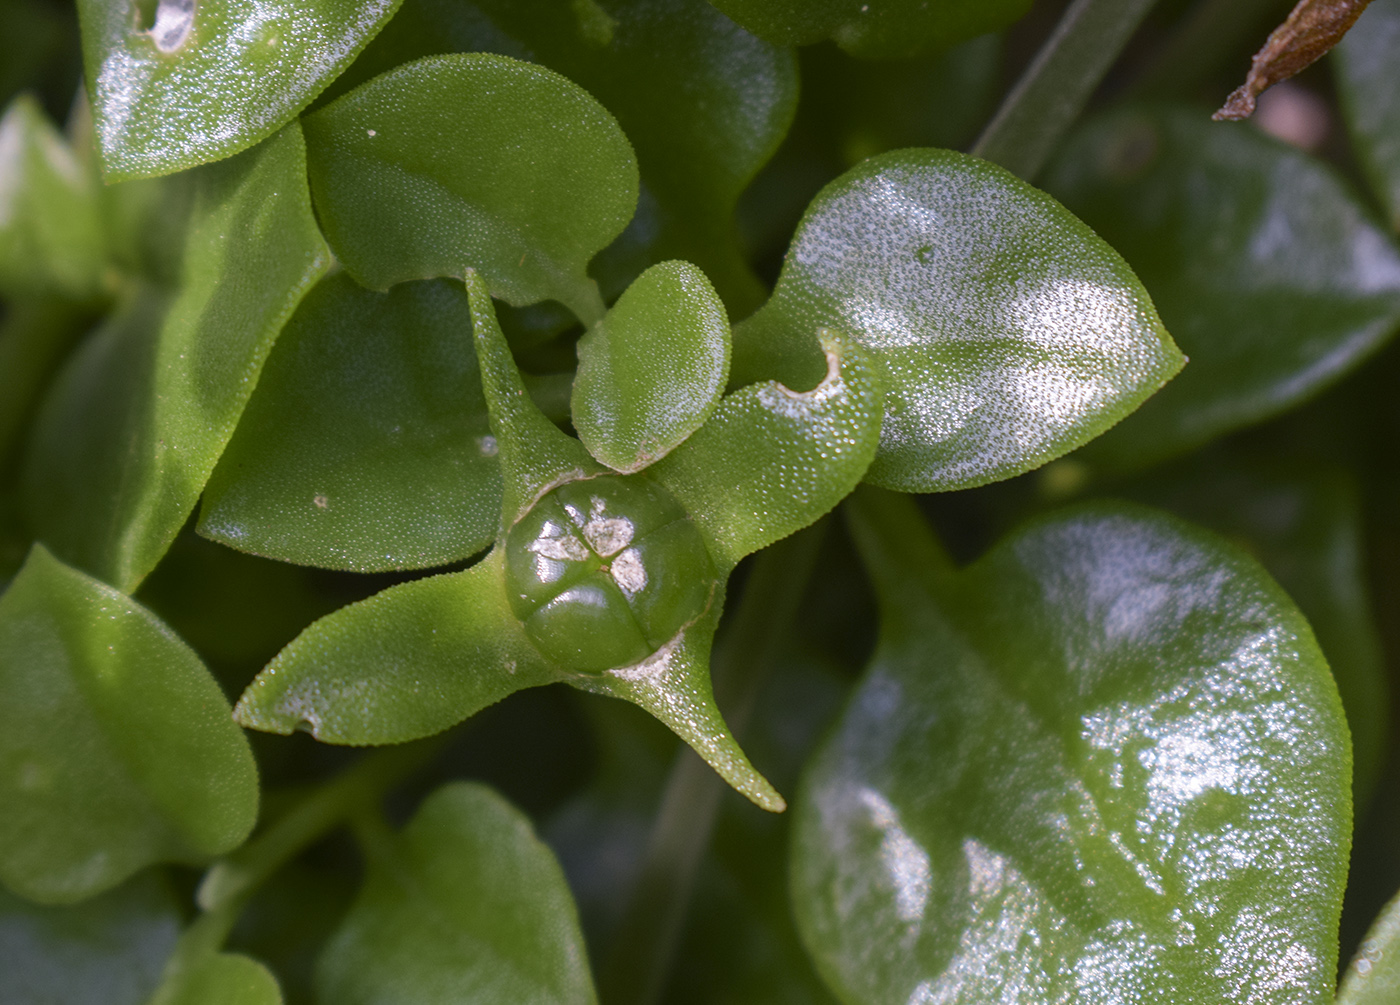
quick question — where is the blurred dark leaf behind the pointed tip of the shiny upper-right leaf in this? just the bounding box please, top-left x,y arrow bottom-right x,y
1046,108 -> 1400,466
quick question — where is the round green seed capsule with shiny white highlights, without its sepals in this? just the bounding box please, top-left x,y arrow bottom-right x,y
505,475 -> 717,672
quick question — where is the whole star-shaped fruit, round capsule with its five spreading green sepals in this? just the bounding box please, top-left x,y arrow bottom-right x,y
235,262 -> 883,810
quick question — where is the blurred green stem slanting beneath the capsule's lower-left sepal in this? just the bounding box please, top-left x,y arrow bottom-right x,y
196,736 -> 442,924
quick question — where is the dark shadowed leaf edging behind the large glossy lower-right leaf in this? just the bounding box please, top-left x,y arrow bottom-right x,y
1119,455 -> 1390,809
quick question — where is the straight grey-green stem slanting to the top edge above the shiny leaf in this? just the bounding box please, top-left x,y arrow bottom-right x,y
972,0 -> 1154,182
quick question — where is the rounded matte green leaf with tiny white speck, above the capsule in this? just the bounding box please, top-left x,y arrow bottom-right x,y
305,53 -> 637,323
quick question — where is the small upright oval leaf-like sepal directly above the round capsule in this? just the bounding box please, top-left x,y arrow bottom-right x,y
573,262 -> 729,472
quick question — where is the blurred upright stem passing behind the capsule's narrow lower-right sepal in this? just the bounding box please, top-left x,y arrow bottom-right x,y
599,521 -> 827,1005
